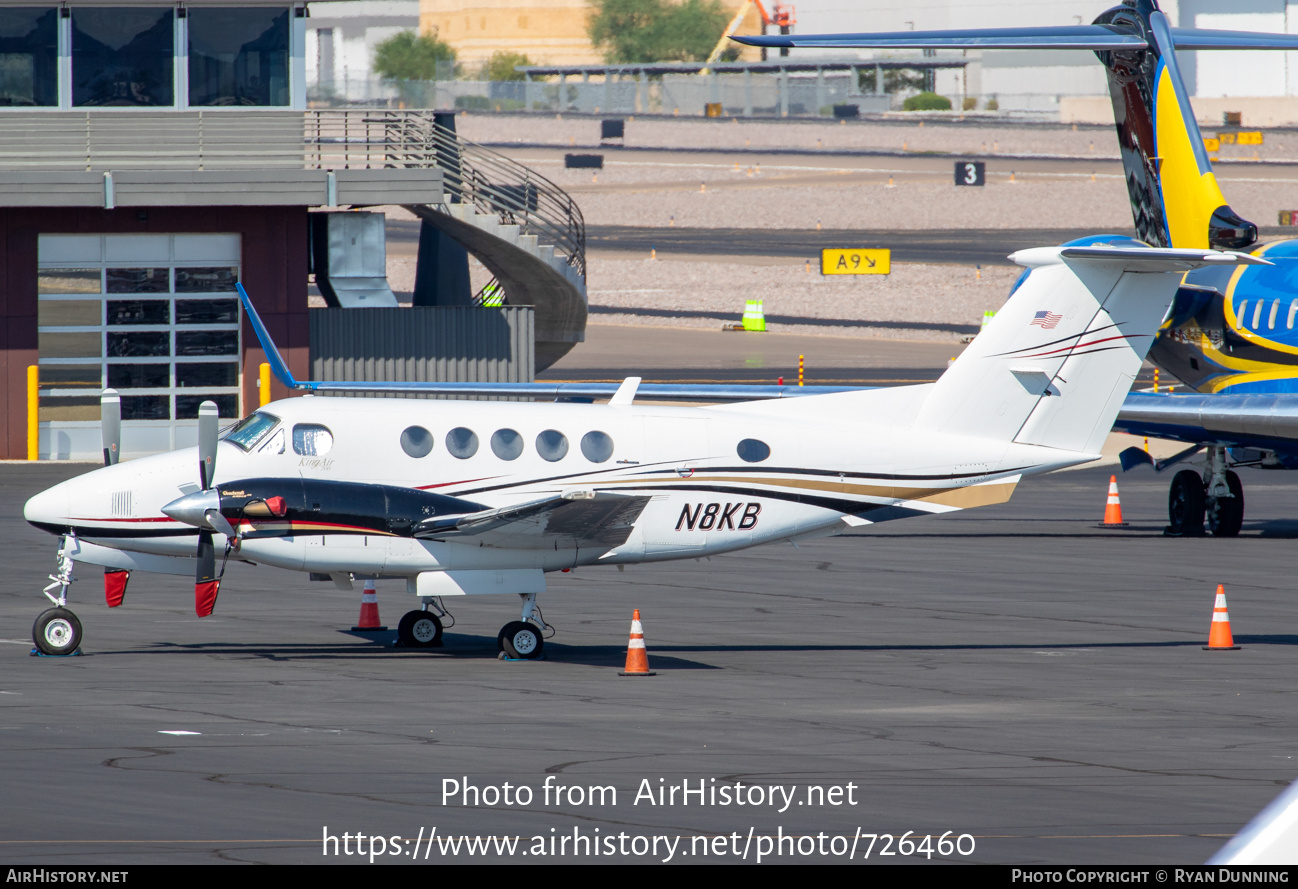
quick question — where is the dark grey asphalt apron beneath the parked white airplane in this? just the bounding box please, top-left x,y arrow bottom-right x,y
0,454 -> 1298,866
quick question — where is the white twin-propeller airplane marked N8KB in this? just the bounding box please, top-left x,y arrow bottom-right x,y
25,237 -> 1268,658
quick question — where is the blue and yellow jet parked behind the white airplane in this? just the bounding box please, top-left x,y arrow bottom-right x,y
733,0 -> 1298,536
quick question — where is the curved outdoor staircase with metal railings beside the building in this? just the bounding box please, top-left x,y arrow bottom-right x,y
308,110 -> 587,370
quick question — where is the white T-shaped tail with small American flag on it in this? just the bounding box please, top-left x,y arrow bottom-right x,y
915,237 -> 1267,454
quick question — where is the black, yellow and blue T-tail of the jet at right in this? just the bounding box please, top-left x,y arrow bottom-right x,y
732,0 -> 1298,249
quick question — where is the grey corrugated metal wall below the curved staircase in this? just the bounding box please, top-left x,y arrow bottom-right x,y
309,306 -> 536,397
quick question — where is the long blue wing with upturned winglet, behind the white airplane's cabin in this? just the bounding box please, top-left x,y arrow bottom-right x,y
235,284 -> 872,404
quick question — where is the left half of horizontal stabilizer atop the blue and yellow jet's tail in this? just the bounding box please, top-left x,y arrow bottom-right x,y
731,25 -> 1149,49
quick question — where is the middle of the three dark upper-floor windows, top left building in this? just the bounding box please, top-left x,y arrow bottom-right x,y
73,6 -> 175,107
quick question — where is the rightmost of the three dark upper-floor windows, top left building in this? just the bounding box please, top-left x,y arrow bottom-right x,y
188,6 -> 289,105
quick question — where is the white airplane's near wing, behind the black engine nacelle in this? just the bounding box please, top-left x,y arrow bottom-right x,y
414,491 -> 649,549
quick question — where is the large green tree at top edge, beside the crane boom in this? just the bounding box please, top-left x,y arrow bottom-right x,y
587,0 -> 737,65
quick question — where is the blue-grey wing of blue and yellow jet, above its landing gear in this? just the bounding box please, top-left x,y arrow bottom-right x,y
1114,392 -> 1298,450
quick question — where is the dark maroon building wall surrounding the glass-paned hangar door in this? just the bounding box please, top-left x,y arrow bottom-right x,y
0,206 -> 310,459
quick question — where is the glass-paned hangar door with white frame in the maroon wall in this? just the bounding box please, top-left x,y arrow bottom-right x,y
38,234 -> 241,459
